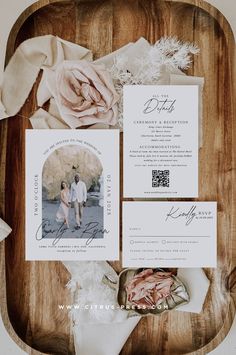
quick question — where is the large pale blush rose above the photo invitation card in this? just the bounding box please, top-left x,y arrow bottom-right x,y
47,60 -> 119,128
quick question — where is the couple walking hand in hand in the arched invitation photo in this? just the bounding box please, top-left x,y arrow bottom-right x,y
56,174 -> 87,229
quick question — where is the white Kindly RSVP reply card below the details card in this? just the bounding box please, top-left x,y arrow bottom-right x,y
122,201 -> 217,268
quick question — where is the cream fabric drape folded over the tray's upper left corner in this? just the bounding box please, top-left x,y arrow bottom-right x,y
0,35 -> 92,118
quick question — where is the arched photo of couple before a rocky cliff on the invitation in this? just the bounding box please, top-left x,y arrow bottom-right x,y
42,145 -> 104,238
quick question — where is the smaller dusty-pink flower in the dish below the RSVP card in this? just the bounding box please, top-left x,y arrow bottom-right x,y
126,269 -> 174,309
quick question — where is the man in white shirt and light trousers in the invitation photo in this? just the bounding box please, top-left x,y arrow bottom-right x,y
70,174 -> 87,229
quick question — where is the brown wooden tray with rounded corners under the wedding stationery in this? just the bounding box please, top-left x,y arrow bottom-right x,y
0,0 -> 236,355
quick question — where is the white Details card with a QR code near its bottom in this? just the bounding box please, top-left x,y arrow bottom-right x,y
123,85 -> 198,198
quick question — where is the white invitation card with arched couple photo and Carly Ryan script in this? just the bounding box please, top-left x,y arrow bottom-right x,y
26,129 -> 119,260
